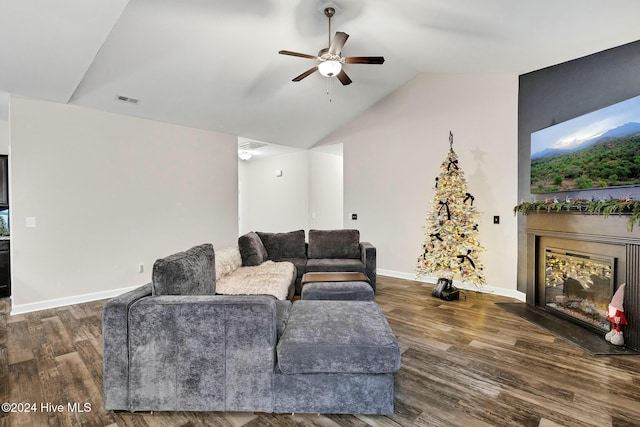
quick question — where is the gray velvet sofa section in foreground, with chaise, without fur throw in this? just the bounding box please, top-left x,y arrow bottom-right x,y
103,244 -> 400,414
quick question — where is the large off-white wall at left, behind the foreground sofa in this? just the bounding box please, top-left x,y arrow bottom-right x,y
10,96 -> 238,312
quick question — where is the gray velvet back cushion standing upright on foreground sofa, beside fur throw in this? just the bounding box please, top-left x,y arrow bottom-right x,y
151,243 -> 216,295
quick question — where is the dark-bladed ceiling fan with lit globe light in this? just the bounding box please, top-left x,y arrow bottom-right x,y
278,7 -> 384,86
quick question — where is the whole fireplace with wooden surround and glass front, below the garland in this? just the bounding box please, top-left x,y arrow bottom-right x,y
526,212 -> 640,351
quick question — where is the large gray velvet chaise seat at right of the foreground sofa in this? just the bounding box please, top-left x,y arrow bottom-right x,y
273,300 -> 400,414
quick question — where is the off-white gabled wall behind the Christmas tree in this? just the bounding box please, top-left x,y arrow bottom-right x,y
323,74 -> 518,290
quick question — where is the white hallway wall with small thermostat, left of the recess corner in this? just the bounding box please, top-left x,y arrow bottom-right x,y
238,151 -> 309,234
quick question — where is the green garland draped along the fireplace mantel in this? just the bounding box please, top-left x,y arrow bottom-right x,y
513,197 -> 640,232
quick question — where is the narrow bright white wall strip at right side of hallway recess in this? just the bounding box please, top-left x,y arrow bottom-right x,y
308,144 -> 344,230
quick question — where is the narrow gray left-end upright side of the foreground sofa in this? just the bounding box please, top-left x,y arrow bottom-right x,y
102,283 -> 151,410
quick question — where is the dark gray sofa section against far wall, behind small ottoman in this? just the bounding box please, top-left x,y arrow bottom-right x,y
238,229 -> 376,295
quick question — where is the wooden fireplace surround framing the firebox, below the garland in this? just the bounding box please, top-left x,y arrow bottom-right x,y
526,211 -> 640,351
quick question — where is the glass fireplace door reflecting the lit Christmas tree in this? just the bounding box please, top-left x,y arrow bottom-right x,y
544,248 -> 615,332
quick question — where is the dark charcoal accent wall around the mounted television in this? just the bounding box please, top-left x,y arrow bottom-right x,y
518,41 -> 640,292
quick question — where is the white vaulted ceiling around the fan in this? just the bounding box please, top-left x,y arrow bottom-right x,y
0,0 -> 640,148
